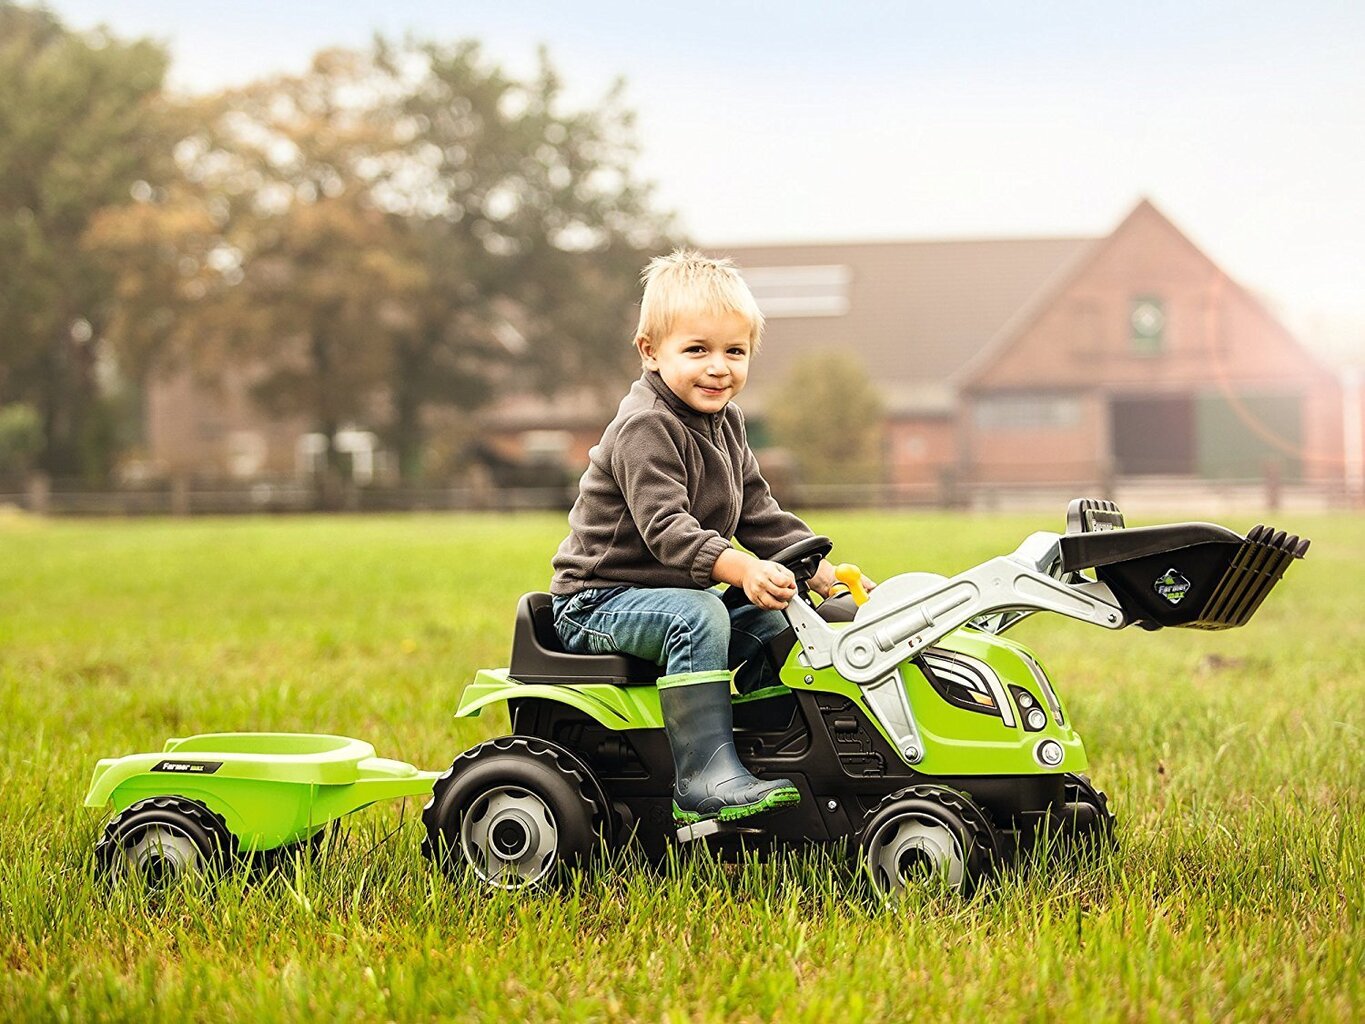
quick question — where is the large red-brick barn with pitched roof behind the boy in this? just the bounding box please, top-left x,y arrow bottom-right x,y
711,199 -> 1343,496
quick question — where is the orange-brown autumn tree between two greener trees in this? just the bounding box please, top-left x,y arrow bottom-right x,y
91,51 -> 412,505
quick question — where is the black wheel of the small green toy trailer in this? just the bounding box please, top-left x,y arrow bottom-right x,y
94,796 -> 238,889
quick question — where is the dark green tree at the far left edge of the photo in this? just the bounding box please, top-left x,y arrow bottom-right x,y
0,3 -> 168,477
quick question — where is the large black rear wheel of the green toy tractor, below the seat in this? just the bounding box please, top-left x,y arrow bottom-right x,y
422,736 -> 612,889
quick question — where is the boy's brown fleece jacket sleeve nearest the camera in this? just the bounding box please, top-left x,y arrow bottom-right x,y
612,412 -> 730,587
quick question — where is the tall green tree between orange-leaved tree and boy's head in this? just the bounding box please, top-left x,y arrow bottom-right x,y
374,41 -> 670,478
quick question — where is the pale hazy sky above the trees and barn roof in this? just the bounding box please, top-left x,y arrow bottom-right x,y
48,0 -> 1365,365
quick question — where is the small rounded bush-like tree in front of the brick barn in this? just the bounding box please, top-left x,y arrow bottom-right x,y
764,352 -> 883,485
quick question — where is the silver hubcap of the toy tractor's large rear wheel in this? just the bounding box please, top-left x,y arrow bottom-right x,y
460,786 -> 560,889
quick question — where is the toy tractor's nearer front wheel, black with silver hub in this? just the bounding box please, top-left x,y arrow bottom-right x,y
859,785 -> 1001,896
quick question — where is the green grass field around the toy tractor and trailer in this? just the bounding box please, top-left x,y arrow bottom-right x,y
0,509 -> 1365,1021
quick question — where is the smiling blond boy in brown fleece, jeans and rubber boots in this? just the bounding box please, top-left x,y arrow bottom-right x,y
550,250 -> 834,823
